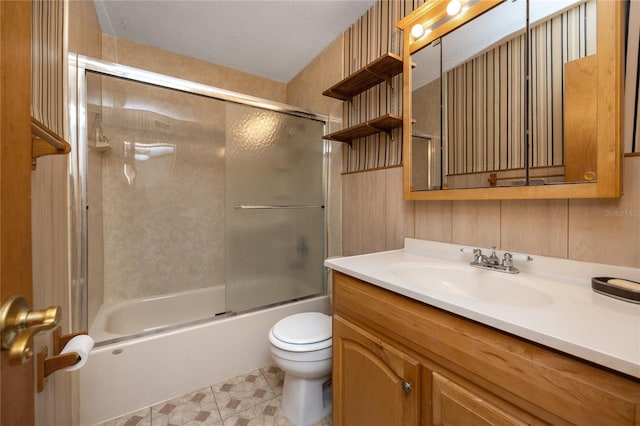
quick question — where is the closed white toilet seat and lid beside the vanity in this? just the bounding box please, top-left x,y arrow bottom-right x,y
269,312 -> 332,352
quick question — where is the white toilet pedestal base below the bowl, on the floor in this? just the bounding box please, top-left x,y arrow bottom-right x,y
282,373 -> 331,426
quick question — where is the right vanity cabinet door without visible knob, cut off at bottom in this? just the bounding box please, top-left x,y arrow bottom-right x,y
431,373 -> 538,426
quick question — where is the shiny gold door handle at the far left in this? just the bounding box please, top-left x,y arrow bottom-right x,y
0,296 -> 62,365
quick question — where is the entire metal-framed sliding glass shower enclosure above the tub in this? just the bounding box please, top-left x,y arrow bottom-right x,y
70,57 -> 327,343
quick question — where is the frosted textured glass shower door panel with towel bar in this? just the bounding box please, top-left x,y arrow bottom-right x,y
225,102 -> 324,312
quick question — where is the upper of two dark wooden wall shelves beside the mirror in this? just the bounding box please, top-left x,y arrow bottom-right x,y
322,52 -> 402,101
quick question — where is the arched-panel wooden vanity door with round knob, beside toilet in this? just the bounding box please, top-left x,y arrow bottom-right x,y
333,315 -> 420,426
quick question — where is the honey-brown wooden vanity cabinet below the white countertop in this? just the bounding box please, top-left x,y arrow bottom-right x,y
333,271 -> 640,426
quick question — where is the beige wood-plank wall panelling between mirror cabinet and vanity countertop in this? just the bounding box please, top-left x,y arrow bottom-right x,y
342,2 -> 640,267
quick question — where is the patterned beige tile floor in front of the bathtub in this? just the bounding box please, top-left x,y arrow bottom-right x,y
101,365 -> 331,426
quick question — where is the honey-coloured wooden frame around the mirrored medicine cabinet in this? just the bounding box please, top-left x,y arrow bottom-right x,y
396,0 -> 625,200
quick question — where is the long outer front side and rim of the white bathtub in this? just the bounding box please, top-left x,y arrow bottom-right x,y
80,292 -> 330,426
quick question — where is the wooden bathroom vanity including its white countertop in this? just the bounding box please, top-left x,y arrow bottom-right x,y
326,239 -> 640,426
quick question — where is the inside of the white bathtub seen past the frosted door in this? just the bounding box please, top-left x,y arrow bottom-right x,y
89,285 -> 225,342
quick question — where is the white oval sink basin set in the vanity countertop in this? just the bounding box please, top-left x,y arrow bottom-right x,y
392,263 -> 553,307
